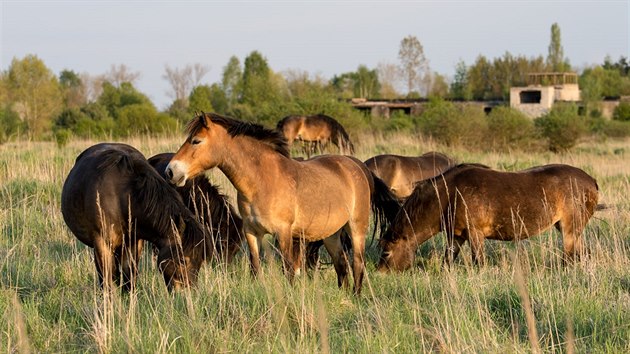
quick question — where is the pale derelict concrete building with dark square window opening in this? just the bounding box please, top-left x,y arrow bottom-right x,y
510,72 -> 580,118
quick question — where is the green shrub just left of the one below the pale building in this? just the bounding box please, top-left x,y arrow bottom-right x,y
486,107 -> 535,150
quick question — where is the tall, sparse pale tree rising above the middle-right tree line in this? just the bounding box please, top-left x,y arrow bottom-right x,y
398,35 -> 429,93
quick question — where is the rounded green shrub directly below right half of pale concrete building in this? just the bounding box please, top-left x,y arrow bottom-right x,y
534,105 -> 587,152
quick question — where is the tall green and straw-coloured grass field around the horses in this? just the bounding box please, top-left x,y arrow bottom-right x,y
0,135 -> 630,353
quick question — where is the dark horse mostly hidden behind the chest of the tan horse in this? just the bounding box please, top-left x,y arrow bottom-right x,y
148,152 -> 245,263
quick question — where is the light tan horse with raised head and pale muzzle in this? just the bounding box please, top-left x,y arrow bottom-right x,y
165,113 -> 390,294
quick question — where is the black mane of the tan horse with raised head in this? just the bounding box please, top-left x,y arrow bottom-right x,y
187,113 -> 290,157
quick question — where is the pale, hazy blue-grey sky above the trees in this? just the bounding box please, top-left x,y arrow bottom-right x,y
0,0 -> 630,109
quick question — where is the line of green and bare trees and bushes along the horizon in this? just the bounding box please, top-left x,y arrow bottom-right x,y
0,24 -> 630,142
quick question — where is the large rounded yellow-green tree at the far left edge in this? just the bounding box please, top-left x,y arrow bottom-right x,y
6,55 -> 63,138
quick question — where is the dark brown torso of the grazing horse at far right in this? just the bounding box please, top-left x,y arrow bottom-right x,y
446,165 -> 598,239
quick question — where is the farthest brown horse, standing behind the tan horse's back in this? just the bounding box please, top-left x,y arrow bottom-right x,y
276,114 -> 354,157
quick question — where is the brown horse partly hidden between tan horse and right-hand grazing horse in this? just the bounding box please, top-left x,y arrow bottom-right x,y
365,151 -> 455,202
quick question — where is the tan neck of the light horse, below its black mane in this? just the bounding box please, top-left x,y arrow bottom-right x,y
217,136 -> 282,197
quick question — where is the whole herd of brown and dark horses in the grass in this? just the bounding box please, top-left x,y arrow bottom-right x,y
61,113 -> 598,294
